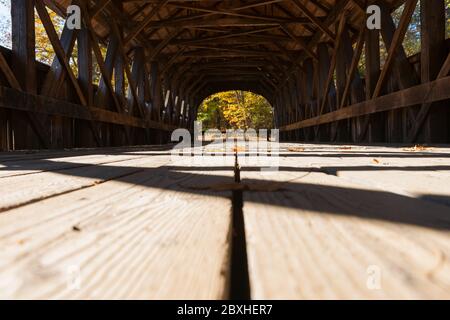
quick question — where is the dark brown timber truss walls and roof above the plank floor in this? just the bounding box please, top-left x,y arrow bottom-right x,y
0,0 -> 450,150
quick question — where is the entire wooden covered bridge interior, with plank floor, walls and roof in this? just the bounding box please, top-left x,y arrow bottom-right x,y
0,0 -> 450,299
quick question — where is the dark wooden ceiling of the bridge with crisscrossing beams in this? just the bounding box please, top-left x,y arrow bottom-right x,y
47,0 -> 403,98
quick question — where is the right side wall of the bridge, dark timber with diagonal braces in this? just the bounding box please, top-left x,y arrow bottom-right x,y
275,0 -> 450,143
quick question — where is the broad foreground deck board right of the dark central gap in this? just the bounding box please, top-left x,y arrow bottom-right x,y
241,146 -> 450,299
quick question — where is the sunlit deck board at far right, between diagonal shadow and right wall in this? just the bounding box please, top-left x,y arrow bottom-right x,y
282,144 -> 450,206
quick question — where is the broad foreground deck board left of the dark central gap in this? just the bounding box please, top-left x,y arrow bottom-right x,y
0,151 -> 232,299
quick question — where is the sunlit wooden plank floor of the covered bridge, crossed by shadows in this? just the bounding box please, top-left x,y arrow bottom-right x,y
0,144 -> 450,299
